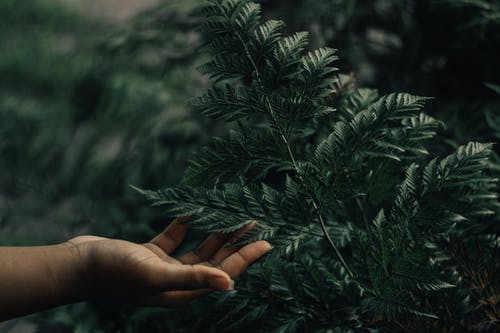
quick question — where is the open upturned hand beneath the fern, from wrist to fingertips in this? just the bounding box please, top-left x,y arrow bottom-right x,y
67,218 -> 271,306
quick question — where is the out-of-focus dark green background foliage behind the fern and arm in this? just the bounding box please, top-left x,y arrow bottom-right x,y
0,0 -> 500,333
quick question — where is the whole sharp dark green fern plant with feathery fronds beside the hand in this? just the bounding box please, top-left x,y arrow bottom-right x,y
140,0 -> 498,332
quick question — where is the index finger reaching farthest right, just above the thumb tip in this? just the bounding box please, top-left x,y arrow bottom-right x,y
219,241 -> 272,279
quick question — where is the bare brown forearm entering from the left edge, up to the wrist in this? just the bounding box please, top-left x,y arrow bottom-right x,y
0,243 -> 88,321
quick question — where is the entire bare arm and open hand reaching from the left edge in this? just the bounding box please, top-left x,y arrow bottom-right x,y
0,218 -> 271,321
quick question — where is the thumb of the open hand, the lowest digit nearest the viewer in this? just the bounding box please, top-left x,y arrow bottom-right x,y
155,265 -> 233,290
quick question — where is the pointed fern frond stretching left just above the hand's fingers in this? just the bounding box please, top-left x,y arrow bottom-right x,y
140,181 -> 321,254
